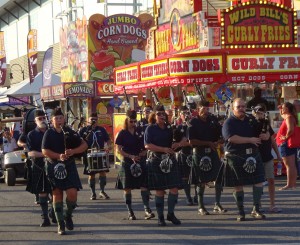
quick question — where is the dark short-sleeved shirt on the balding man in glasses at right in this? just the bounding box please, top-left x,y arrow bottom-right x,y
222,115 -> 259,153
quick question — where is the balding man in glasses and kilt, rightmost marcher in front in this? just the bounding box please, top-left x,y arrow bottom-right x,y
217,98 -> 270,221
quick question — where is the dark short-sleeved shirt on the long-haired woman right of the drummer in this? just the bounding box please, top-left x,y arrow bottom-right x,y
115,129 -> 143,155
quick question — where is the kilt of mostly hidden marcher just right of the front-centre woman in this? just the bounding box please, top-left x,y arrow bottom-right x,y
176,147 -> 192,179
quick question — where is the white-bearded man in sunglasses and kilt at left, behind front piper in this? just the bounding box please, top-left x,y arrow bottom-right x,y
25,110 -> 51,227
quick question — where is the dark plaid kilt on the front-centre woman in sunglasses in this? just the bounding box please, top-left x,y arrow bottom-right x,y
147,152 -> 182,190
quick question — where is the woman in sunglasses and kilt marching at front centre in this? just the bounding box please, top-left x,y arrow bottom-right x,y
144,105 -> 181,226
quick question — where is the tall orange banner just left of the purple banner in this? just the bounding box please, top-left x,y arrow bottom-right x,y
27,29 -> 37,83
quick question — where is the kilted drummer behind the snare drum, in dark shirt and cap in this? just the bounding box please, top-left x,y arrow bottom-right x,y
79,113 -> 111,200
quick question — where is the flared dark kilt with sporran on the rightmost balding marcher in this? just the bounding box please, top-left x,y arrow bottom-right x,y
217,151 -> 265,187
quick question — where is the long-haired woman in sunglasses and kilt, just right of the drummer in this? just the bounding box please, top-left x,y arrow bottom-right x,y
115,110 -> 155,220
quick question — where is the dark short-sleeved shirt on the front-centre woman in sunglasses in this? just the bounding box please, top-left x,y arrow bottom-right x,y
144,124 -> 173,147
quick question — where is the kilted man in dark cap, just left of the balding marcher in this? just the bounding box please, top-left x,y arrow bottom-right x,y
188,101 -> 227,215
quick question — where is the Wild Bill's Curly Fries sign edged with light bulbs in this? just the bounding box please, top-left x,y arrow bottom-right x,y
221,2 -> 296,48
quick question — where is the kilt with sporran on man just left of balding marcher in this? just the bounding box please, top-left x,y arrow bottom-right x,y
189,147 -> 221,185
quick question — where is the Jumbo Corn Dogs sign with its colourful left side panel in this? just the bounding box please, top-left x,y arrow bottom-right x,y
60,14 -> 154,82
